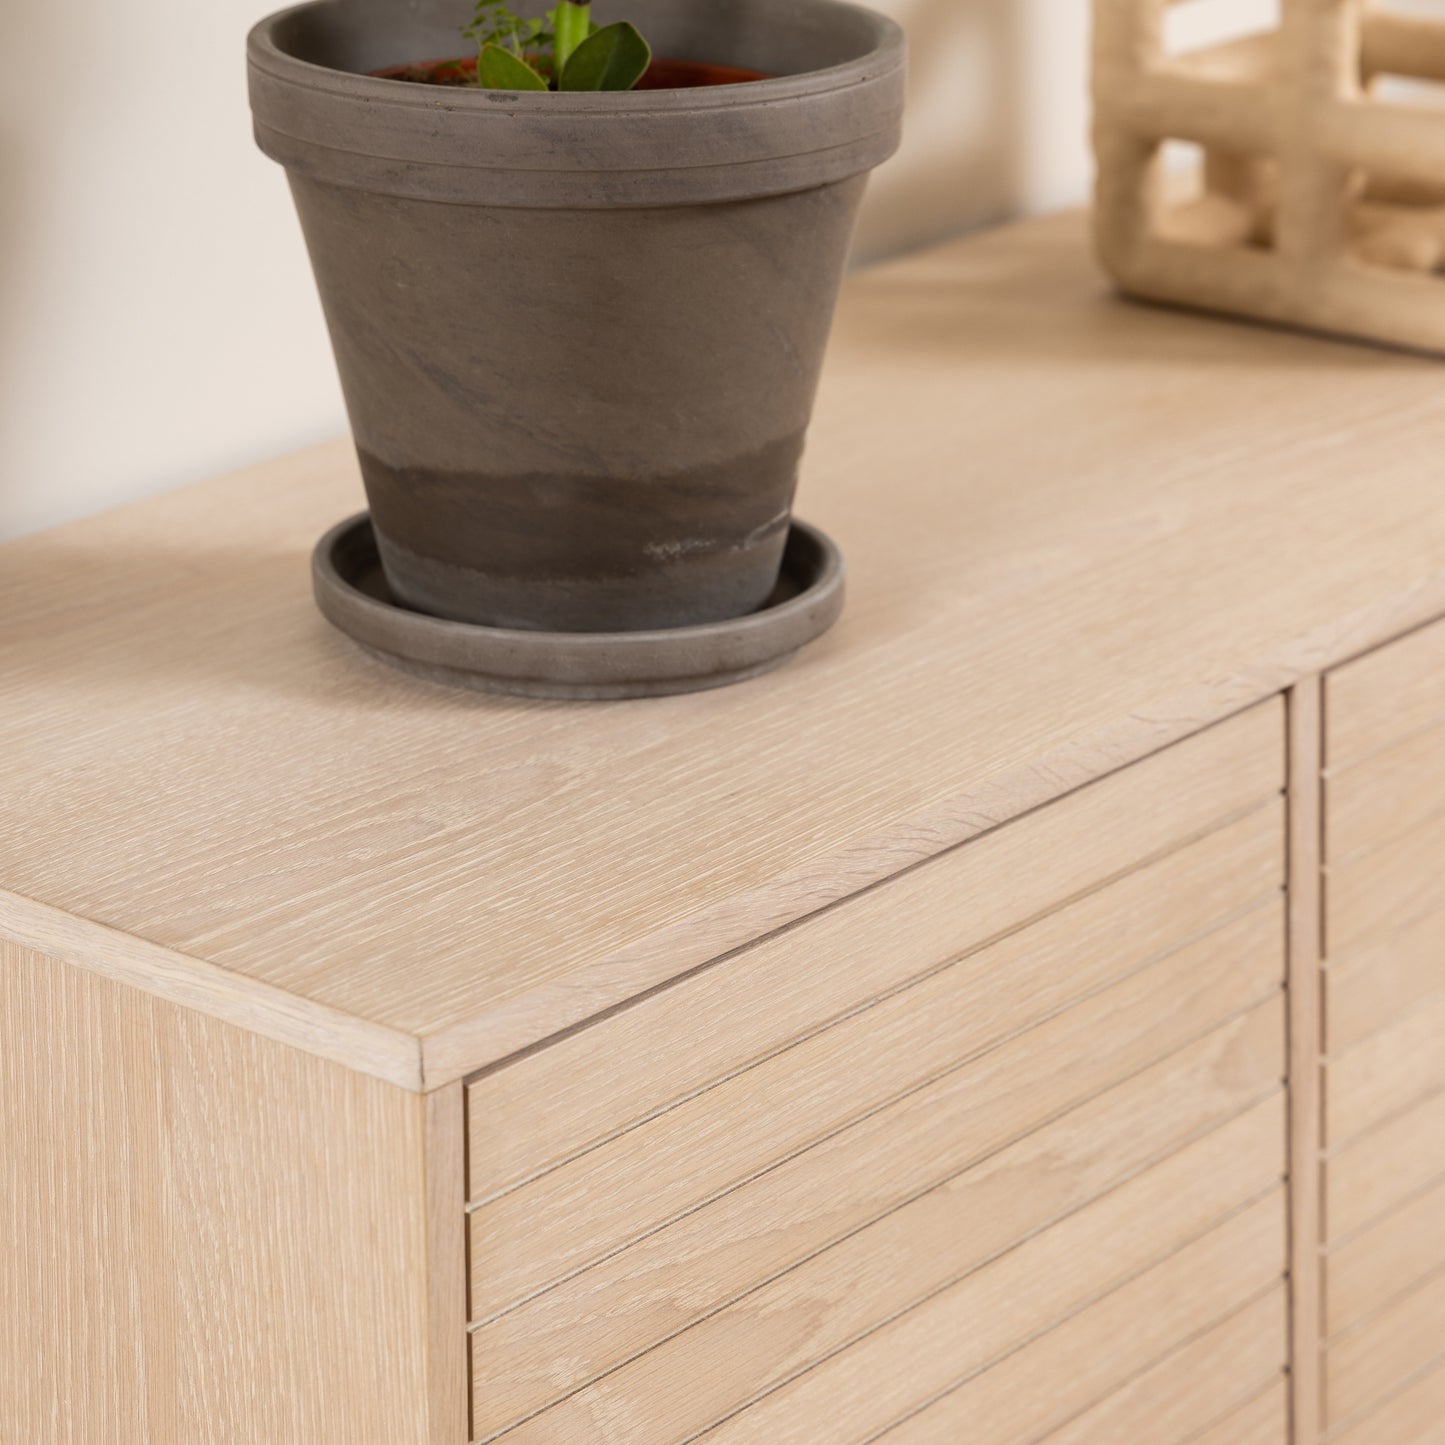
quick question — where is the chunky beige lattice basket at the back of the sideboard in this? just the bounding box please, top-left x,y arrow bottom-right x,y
1094,0 -> 1445,353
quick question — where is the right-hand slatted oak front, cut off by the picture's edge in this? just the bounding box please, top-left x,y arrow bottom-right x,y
1324,624 -> 1445,1445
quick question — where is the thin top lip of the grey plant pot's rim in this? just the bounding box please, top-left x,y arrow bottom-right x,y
247,0 -> 907,120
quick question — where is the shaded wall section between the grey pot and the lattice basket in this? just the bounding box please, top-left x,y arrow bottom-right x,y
855,0 -> 1088,263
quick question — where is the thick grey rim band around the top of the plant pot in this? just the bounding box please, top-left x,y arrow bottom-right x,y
249,0 -> 907,210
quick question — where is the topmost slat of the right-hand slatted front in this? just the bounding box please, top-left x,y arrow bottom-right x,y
1325,612 -> 1445,770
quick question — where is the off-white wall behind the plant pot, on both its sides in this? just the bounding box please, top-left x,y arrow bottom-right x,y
0,0 -> 1088,536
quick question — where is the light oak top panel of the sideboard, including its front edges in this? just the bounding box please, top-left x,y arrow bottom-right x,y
0,206 -> 1445,1088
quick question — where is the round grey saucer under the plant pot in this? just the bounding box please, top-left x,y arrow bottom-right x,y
311,512 -> 844,699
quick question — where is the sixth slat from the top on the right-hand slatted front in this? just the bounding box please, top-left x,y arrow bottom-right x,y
1325,1092 -> 1445,1241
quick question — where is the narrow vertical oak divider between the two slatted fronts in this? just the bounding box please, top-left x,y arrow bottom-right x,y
1286,678 -> 1325,1445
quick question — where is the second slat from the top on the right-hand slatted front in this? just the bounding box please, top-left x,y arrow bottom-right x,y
1325,725 -> 1445,863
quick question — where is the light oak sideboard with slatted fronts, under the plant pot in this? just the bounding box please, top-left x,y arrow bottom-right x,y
0,210 -> 1445,1445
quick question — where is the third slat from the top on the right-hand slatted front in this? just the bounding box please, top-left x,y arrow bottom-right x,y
1325,814 -> 1445,962
